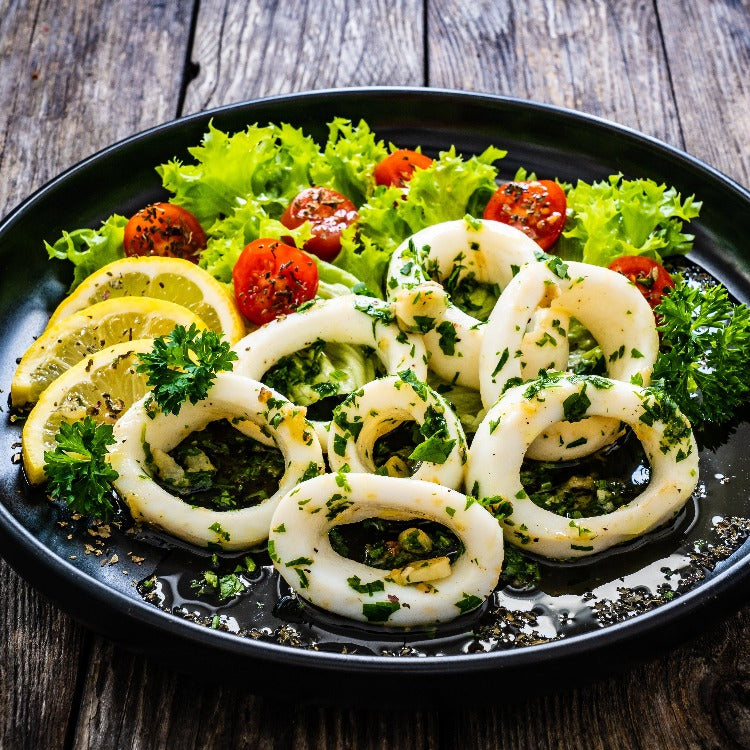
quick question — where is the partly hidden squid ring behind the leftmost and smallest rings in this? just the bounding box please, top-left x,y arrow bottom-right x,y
232,294 -> 427,448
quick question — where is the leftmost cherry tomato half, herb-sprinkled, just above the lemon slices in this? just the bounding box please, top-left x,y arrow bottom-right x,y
125,203 -> 206,263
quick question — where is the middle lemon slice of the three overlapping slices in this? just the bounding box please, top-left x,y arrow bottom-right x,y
10,297 -> 206,406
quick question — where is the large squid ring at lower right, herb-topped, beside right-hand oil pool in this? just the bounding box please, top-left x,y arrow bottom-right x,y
467,375 -> 698,559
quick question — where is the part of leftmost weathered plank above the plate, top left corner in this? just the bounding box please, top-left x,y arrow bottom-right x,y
0,0 -> 197,213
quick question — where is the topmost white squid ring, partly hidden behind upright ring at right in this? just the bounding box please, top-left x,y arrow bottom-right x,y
386,219 -> 567,388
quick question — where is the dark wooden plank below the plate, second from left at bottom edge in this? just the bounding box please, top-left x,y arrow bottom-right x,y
70,644 -> 438,750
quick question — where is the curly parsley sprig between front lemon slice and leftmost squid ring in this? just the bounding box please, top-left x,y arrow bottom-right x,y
136,323 -> 237,414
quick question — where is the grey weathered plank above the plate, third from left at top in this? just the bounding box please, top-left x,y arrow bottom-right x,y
427,0 -> 682,146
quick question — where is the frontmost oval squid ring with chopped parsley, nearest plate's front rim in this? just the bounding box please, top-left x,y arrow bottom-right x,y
268,473 -> 503,626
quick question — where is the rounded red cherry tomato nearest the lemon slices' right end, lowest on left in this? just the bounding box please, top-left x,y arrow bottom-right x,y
232,238 -> 318,325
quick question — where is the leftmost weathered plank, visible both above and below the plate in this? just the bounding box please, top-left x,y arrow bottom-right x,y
0,0 -> 197,750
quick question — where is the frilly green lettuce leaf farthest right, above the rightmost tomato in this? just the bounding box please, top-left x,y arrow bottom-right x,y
554,175 -> 701,266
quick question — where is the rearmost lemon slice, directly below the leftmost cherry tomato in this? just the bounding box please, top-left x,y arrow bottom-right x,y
50,256 -> 245,344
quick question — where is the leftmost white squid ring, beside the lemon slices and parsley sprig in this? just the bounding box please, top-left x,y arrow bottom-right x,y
110,373 -> 325,550
